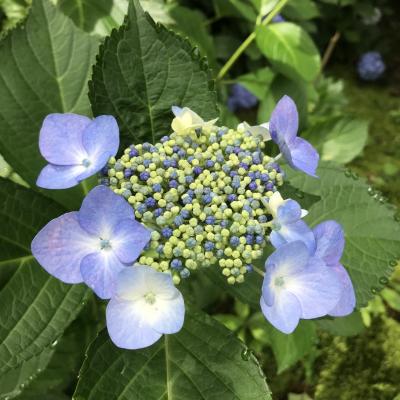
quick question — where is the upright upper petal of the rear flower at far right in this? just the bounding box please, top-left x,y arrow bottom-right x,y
313,221 -> 344,266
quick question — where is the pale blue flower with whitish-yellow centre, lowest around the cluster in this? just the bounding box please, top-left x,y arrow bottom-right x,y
106,265 -> 185,349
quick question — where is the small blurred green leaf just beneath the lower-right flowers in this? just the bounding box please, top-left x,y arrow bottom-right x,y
315,311 -> 365,336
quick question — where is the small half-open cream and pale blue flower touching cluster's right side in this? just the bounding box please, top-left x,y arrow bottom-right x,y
267,192 -> 315,251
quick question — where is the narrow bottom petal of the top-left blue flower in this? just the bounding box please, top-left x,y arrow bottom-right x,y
36,164 -> 85,189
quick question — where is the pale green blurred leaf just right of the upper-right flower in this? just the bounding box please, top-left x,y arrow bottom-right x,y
306,117 -> 368,164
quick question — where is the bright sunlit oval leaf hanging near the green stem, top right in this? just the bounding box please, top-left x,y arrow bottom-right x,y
256,22 -> 321,82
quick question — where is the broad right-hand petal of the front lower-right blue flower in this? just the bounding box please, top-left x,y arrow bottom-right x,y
285,258 -> 342,319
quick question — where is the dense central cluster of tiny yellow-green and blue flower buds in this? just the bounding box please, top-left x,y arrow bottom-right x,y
102,115 -> 283,284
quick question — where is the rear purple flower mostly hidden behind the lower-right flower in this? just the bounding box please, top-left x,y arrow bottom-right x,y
313,221 -> 356,317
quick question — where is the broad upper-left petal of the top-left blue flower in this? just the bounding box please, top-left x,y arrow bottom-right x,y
39,114 -> 91,165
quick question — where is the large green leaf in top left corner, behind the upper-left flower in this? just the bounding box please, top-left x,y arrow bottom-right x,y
0,0 -> 97,207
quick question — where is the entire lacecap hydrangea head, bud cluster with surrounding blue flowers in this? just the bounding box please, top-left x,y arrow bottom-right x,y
32,96 -> 355,349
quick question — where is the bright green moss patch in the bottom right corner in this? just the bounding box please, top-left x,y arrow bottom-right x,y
315,318 -> 400,400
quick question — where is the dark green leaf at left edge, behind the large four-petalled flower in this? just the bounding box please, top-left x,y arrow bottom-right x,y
0,179 -> 88,375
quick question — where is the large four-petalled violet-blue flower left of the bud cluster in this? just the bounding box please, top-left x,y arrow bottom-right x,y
31,186 -> 151,299
